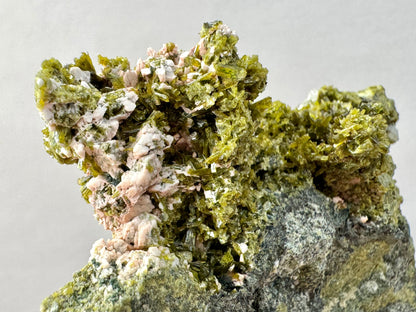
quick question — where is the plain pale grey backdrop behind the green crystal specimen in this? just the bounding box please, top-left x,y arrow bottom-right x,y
0,0 -> 416,312
